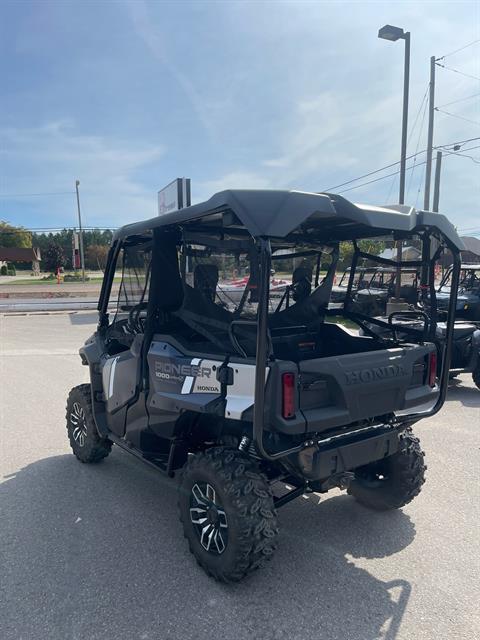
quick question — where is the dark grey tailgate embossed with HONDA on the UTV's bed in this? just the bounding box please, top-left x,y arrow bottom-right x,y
299,344 -> 438,432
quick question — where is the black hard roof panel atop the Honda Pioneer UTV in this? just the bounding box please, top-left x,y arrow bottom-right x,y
115,189 -> 464,250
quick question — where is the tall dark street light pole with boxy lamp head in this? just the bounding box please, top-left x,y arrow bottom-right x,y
378,24 -> 410,300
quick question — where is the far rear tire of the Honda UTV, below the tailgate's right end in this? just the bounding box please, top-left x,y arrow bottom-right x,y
348,429 -> 427,511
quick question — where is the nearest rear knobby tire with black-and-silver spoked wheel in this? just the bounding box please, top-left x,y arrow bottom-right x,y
178,447 -> 278,582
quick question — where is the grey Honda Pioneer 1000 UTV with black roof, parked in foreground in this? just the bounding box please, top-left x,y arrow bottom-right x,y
66,190 -> 462,581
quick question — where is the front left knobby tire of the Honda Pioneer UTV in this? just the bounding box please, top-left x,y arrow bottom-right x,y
66,384 -> 112,462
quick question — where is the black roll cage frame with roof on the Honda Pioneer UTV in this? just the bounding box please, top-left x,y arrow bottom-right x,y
98,191 -> 463,461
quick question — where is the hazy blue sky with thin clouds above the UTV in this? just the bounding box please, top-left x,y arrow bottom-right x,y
0,0 -> 480,233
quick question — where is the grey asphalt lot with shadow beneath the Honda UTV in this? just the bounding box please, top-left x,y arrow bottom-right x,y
0,312 -> 480,640
